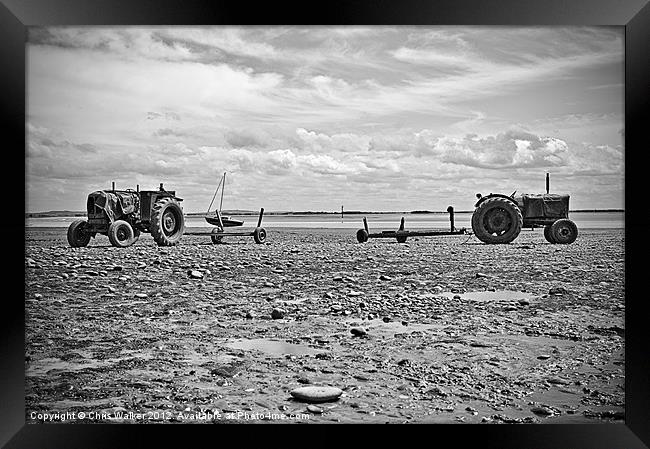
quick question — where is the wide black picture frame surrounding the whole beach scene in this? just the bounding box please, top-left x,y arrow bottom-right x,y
0,0 -> 650,449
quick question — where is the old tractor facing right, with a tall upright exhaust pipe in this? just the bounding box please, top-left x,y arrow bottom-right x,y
472,173 -> 578,244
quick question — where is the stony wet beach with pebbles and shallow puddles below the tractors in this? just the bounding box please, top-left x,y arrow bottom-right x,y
25,228 -> 625,424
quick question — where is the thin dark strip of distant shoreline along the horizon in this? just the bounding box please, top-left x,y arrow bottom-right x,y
25,209 -> 625,218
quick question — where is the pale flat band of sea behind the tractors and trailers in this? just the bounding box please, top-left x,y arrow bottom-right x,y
25,211 -> 625,232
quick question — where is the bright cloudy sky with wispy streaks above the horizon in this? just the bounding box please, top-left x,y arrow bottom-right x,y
26,26 -> 624,212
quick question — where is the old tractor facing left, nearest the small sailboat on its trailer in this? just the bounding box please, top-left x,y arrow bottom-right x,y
68,184 -> 185,248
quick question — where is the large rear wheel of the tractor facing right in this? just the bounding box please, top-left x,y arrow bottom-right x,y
472,196 -> 524,243
